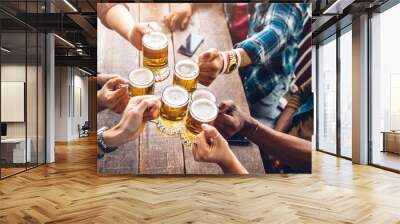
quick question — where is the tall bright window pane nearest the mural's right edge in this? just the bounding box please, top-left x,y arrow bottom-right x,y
317,39 -> 336,153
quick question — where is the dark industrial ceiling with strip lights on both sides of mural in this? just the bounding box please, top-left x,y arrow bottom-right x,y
0,0 -> 394,72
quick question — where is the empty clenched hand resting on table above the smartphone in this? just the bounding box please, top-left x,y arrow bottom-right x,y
164,3 -> 192,31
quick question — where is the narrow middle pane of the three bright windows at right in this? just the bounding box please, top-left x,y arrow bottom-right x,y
340,30 -> 353,158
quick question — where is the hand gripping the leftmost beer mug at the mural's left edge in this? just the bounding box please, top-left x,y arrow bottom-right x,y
97,77 -> 129,113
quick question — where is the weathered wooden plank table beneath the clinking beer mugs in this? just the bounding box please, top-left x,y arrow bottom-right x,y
97,3 -> 265,174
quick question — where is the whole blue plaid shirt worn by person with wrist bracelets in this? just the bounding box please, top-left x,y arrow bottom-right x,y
236,3 -> 311,103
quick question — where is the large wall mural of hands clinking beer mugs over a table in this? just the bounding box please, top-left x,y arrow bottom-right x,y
97,3 -> 314,175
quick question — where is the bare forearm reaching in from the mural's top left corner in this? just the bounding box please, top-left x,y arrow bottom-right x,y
102,4 -> 135,41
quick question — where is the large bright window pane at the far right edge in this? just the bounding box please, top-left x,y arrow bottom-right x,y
371,4 -> 400,170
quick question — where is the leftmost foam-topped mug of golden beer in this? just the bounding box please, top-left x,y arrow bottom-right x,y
129,68 -> 154,97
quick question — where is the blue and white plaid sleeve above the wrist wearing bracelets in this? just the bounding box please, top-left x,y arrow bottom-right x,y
237,4 -> 304,65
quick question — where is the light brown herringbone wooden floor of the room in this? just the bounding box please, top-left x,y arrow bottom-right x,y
0,138 -> 400,223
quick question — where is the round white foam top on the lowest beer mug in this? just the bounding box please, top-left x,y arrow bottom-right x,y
190,99 -> 218,122
